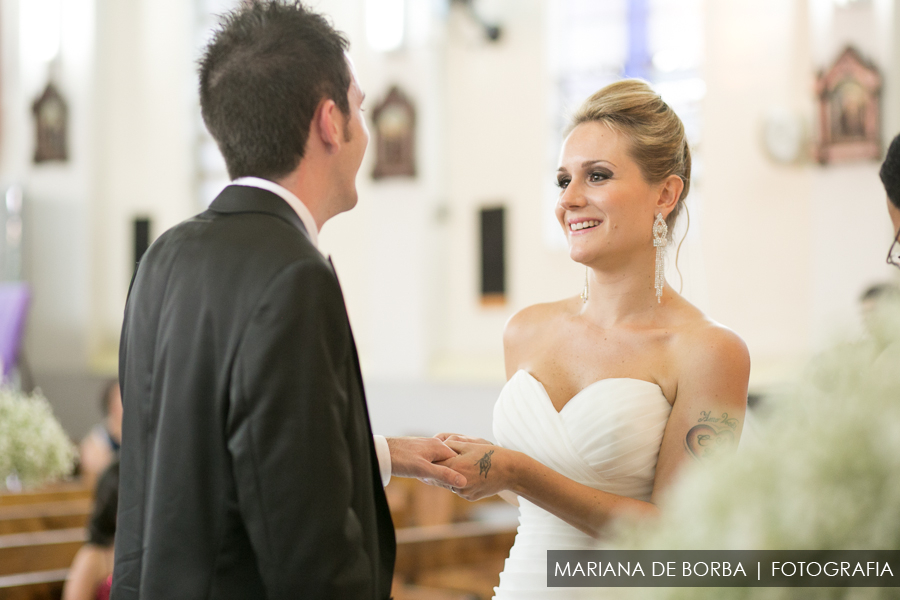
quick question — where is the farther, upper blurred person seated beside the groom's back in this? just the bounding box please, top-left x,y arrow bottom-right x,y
79,379 -> 122,487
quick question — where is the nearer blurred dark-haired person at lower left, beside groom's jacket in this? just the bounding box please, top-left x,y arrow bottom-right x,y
62,462 -> 119,600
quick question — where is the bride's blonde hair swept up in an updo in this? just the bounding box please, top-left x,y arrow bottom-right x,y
566,79 -> 691,238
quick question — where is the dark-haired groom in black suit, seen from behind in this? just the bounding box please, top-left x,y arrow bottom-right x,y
112,1 -> 465,600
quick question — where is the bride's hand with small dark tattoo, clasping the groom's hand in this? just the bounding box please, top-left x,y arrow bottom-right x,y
438,438 -> 517,501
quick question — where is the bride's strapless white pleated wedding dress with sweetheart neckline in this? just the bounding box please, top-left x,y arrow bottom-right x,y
494,371 -> 672,600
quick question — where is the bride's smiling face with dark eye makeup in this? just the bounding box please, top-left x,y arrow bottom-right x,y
556,122 -> 656,265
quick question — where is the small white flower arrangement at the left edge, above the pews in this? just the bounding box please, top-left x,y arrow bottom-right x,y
0,388 -> 76,489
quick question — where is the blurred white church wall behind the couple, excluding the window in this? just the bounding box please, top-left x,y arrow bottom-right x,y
7,0 -> 900,408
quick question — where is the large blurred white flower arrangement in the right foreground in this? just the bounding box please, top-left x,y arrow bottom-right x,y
619,311 -> 900,600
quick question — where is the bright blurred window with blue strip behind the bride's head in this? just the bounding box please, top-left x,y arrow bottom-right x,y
544,0 -> 706,247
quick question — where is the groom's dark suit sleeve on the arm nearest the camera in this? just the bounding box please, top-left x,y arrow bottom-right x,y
228,259 -> 374,599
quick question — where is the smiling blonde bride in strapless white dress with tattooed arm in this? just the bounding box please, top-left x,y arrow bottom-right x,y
437,80 -> 750,599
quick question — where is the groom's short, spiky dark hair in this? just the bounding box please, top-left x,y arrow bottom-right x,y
200,0 -> 350,180
